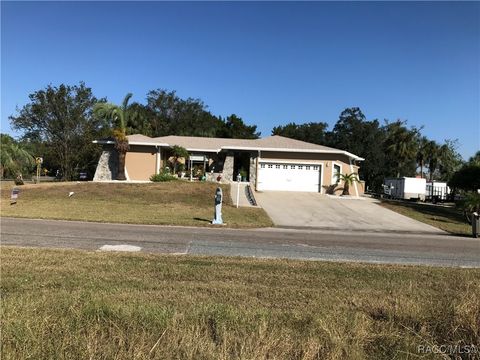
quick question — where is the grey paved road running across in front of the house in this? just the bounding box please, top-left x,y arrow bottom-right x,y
0,218 -> 480,267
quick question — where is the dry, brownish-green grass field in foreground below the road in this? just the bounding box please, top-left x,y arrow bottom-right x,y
0,247 -> 480,360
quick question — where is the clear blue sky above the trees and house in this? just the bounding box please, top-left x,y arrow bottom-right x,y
1,1 -> 480,158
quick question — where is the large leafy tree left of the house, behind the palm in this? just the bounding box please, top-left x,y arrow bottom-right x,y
9,82 -> 105,180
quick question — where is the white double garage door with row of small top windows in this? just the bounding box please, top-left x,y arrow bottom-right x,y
257,162 -> 322,192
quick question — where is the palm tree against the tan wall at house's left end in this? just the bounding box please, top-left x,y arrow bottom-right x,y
93,93 -> 134,180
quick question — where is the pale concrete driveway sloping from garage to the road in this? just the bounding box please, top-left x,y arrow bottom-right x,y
255,191 -> 444,234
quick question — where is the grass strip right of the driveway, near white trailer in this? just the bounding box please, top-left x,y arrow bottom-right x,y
380,199 -> 472,236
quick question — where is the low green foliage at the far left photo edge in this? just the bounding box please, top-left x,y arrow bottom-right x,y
0,134 -> 35,178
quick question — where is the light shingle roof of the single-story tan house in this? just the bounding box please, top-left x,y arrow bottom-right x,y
120,134 -> 363,160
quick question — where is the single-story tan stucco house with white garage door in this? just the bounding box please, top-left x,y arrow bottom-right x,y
94,135 -> 364,196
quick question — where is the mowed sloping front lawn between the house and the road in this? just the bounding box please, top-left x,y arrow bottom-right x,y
1,181 -> 273,228
